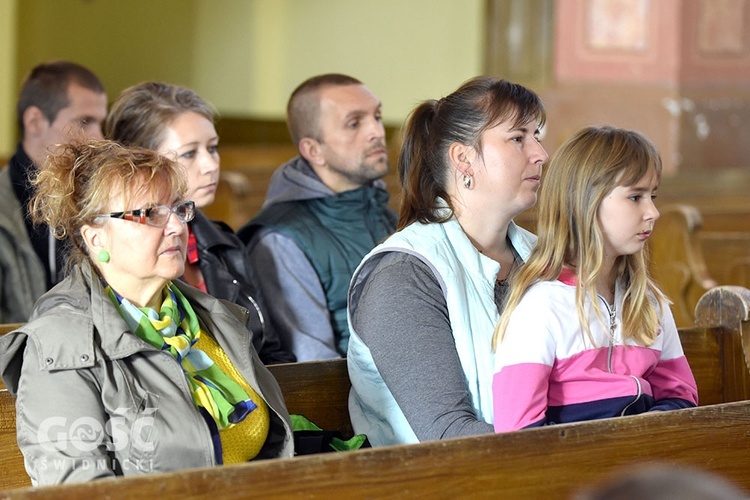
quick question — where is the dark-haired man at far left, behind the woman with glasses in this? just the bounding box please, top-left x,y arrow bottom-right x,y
0,61 -> 107,323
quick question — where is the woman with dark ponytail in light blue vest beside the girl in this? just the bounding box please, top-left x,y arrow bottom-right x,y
348,77 -> 547,446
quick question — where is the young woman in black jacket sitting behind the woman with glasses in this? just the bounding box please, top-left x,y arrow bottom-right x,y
104,82 -> 296,364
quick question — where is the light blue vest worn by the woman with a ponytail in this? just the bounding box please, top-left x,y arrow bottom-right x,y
347,218 -> 536,446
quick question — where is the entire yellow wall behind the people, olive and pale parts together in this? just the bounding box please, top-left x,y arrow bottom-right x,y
0,0 -> 484,155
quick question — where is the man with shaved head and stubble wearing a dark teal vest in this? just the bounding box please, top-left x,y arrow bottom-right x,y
238,74 -> 396,361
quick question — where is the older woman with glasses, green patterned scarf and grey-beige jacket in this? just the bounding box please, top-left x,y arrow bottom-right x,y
0,141 -> 293,485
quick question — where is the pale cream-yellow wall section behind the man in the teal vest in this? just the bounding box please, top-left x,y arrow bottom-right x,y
193,0 -> 484,120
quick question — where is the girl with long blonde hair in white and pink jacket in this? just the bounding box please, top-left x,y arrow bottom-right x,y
492,127 -> 698,432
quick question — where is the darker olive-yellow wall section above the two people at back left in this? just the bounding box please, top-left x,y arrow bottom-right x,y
18,0 -> 196,98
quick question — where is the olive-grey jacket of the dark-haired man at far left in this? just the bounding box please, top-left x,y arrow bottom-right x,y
0,166 -> 47,323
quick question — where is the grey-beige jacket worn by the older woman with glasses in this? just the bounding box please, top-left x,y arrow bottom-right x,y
0,262 -> 293,485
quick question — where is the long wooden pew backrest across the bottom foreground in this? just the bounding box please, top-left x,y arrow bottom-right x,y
3,401 -> 750,500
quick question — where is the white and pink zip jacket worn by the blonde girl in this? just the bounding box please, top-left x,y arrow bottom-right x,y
492,271 -> 698,432
